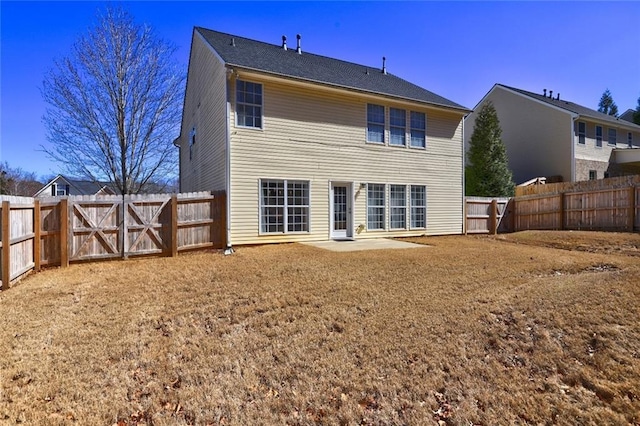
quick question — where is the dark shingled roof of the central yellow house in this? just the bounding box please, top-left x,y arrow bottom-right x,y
195,27 -> 469,111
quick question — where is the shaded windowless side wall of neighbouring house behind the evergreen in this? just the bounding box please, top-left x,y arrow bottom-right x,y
465,86 -> 572,184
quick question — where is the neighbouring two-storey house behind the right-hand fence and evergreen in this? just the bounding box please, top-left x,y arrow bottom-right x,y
465,84 -> 640,183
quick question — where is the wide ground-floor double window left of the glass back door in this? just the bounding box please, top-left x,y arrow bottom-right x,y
260,179 -> 309,233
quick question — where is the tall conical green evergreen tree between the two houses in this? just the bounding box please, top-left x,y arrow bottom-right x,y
465,102 -> 515,197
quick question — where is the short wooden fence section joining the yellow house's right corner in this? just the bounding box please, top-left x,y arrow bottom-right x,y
465,197 -> 509,234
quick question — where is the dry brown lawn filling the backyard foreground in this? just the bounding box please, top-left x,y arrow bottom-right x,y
0,232 -> 640,426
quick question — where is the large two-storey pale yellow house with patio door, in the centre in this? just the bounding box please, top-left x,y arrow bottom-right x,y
175,27 -> 469,246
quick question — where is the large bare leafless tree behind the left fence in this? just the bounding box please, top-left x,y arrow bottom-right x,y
42,8 -> 185,194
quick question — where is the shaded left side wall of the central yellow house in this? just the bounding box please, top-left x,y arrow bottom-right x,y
180,32 -> 227,192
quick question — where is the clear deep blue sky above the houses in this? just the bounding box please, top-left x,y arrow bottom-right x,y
0,0 -> 640,176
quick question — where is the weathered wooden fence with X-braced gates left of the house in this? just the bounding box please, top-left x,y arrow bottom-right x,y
0,191 -> 226,290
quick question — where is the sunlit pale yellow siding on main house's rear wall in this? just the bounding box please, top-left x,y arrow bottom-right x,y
230,73 -> 462,244
